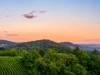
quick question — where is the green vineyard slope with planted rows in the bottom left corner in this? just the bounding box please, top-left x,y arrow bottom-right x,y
0,57 -> 28,75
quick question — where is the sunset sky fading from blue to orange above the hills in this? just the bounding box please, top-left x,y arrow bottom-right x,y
0,0 -> 100,44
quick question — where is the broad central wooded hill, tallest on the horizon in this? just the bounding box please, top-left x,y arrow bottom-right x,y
14,39 -> 71,52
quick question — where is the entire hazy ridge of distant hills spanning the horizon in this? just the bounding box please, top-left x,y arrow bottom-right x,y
0,39 -> 100,51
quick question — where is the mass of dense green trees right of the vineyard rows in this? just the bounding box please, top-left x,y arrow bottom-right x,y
21,47 -> 100,75
